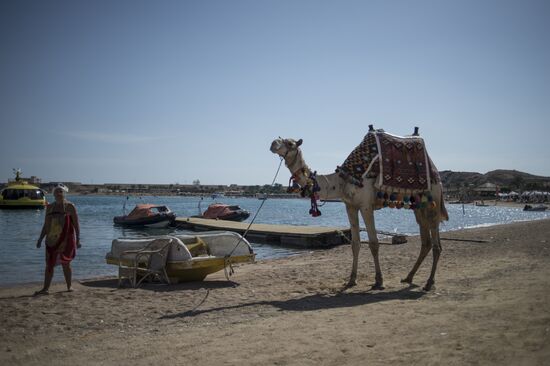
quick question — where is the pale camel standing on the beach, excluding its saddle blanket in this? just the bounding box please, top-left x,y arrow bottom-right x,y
270,125 -> 448,291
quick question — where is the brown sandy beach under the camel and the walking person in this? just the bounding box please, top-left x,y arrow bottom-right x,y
0,220 -> 550,365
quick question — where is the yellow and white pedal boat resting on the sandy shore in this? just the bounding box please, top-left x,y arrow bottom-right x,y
105,231 -> 255,284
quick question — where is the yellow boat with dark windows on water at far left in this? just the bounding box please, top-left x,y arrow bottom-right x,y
0,169 -> 48,209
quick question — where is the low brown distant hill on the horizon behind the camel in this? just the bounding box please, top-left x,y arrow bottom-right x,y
439,169 -> 550,190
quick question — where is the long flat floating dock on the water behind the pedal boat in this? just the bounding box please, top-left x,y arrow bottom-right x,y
175,217 -> 351,248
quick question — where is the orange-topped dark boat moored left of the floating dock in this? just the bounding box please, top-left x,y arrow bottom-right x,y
113,204 -> 176,228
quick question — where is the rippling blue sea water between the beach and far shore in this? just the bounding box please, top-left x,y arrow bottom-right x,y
0,195 -> 550,287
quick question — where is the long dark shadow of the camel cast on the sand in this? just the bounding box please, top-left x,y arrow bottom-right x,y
159,286 -> 426,319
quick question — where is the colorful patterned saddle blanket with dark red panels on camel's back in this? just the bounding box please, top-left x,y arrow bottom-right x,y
336,130 -> 439,193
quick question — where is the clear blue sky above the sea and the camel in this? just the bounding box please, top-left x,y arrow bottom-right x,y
0,0 -> 550,185
